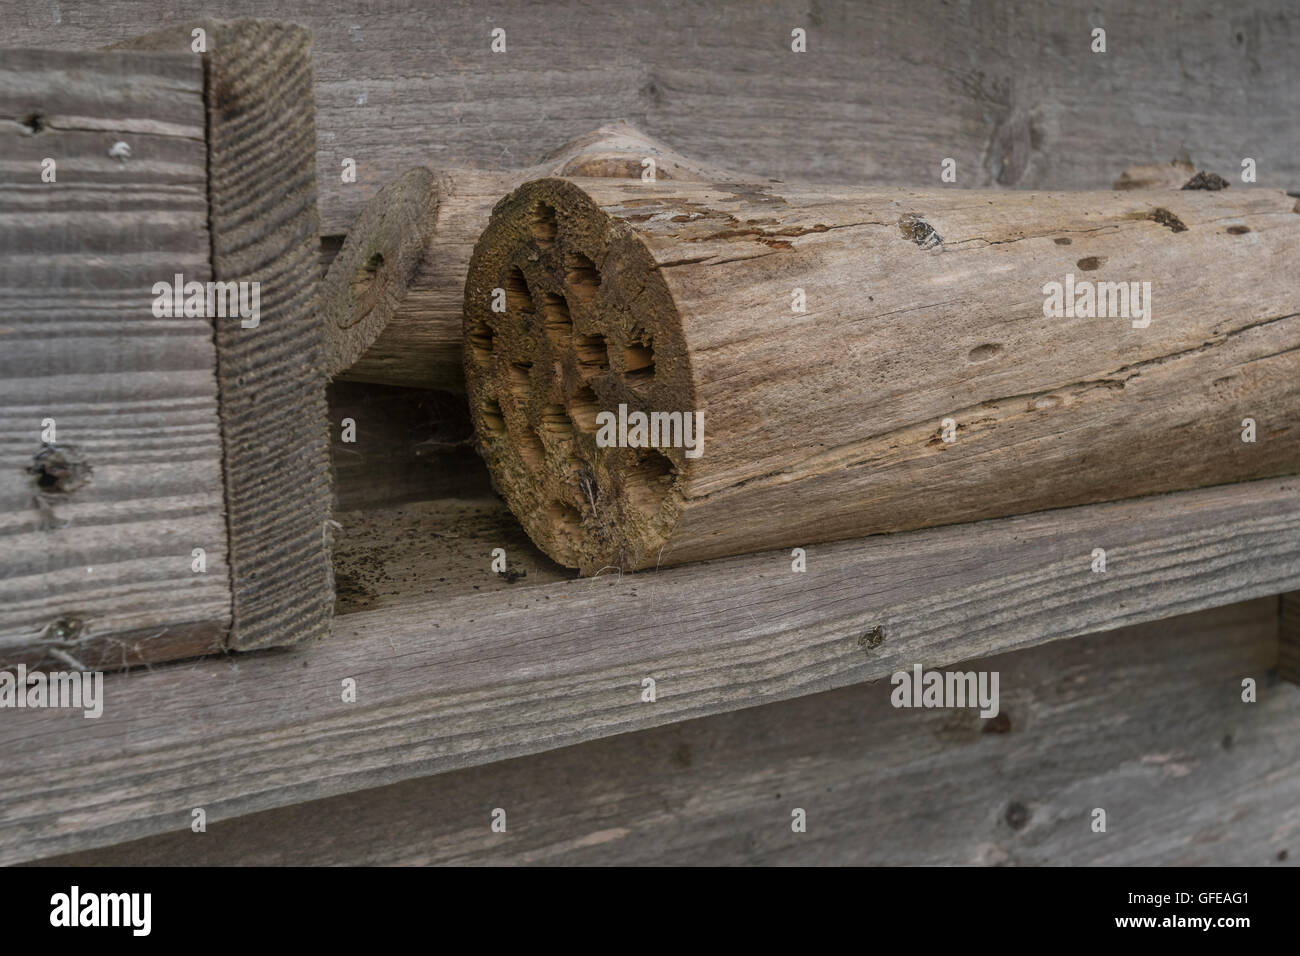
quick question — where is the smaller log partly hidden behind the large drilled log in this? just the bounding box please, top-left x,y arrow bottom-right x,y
321,124 -> 736,392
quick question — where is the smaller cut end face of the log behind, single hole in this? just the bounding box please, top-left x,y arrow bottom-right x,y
321,166 -> 438,381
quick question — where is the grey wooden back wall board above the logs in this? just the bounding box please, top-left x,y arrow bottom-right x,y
0,0 -> 1300,234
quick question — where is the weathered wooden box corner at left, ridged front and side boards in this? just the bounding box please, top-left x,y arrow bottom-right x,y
0,21 -> 333,666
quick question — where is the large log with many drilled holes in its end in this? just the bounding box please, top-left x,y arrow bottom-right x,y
464,178 -> 1300,574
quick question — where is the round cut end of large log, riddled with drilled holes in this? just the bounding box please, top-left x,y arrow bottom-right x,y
464,179 -> 696,574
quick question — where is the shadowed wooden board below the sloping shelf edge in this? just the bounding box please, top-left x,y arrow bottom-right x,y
30,598 -> 1300,866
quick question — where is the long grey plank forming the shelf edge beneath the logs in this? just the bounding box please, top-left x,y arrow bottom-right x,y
0,479 -> 1300,862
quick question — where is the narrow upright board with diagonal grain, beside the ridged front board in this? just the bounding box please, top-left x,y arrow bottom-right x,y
118,20 -> 334,648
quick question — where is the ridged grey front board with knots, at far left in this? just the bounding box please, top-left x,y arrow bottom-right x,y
0,51 -> 230,667
